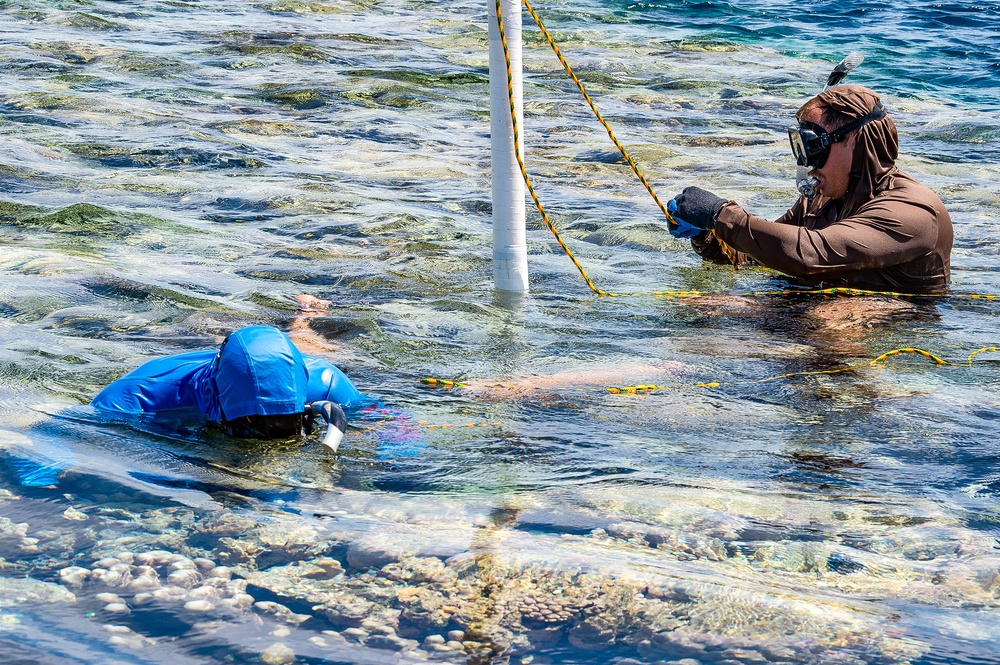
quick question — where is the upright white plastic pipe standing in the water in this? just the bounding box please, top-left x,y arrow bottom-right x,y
486,0 -> 528,292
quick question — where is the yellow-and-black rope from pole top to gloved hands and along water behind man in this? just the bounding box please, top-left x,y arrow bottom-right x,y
496,0 -> 1000,300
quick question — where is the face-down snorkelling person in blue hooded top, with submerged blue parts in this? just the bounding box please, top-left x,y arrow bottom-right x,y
4,326 -> 424,487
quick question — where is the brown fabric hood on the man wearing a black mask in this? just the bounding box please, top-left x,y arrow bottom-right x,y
804,85 -> 899,217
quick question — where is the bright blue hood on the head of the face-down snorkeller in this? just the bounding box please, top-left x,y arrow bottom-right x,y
207,326 -> 309,421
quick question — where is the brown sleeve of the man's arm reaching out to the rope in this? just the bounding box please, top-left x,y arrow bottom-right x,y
715,196 -> 938,278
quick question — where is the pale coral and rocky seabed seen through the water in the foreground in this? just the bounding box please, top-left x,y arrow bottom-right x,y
0,482 -> 1000,665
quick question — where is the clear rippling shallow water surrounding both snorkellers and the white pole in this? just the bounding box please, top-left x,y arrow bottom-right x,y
0,1 -> 1000,663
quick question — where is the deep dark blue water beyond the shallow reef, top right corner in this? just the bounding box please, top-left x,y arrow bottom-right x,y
616,0 -> 1000,111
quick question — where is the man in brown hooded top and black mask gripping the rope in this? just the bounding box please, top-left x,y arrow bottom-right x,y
669,85 -> 953,294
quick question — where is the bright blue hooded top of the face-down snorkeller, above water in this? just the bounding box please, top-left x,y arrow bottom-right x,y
91,326 -> 362,422
